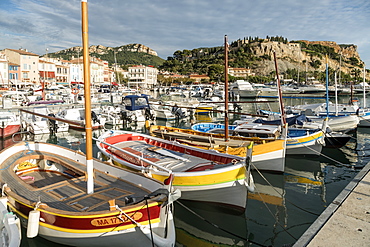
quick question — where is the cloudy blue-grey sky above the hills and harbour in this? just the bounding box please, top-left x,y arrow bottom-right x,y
0,0 -> 370,68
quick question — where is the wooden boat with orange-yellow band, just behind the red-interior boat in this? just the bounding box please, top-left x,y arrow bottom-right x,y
149,125 -> 286,172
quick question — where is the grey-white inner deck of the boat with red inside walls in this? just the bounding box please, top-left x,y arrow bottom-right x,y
109,141 -> 228,172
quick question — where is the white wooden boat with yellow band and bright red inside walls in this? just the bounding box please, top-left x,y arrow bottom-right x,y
97,130 -> 252,212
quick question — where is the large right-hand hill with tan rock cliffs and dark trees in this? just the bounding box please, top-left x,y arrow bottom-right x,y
161,37 -> 364,82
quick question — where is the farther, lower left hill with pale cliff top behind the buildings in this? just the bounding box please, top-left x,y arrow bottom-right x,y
48,44 -> 165,67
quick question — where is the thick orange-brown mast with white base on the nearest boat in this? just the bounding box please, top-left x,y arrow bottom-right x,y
81,0 -> 94,194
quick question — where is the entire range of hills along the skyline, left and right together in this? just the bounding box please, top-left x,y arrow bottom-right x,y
48,36 -> 370,82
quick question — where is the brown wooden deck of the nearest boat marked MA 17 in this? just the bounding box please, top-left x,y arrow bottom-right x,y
0,151 -> 148,213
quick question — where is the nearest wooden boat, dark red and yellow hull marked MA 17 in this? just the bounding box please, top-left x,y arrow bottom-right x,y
0,142 -> 175,246
